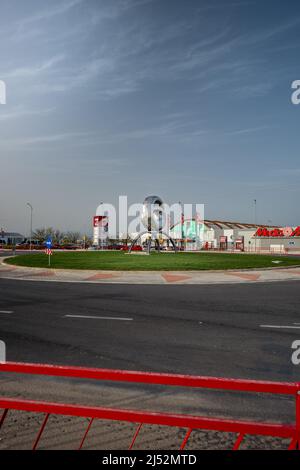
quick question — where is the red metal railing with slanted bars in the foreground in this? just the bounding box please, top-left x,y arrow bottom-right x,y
0,362 -> 300,450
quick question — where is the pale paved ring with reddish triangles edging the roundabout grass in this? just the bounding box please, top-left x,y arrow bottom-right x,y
0,261 -> 300,285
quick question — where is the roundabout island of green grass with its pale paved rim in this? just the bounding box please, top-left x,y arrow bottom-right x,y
0,251 -> 300,285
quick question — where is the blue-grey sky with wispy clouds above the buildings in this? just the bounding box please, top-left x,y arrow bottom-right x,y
0,0 -> 300,235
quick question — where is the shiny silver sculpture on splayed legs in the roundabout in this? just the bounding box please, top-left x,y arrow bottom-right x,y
128,196 -> 177,253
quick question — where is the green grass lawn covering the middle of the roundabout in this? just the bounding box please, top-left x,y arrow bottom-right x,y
6,251 -> 300,271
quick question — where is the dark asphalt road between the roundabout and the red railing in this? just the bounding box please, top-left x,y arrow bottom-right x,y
0,279 -> 300,380
